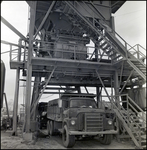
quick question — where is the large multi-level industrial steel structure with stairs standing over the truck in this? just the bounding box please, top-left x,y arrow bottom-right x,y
1,1 -> 146,148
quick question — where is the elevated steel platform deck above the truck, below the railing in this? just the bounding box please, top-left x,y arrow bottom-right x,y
10,57 -> 144,87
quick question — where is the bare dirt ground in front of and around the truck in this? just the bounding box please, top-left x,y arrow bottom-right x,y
1,129 -> 135,149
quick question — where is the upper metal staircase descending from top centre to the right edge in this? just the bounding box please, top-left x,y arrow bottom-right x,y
63,1 -> 146,80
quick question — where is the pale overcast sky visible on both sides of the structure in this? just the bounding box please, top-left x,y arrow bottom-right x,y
1,1 -> 146,109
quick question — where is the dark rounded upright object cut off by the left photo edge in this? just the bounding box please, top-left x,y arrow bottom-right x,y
0,60 -> 6,108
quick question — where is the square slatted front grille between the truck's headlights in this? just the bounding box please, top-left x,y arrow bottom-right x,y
85,113 -> 103,132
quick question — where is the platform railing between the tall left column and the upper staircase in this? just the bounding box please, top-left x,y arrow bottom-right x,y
33,40 -> 111,63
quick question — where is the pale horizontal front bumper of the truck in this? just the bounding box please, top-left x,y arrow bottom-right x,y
68,130 -> 118,135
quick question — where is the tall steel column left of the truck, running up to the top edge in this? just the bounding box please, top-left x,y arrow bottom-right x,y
24,1 -> 37,133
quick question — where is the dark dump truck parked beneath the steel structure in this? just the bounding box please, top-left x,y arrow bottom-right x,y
47,93 -> 118,148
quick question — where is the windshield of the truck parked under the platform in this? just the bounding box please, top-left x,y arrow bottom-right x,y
70,99 -> 97,108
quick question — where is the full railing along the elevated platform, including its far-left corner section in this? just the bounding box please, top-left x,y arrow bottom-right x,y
10,40 -> 111,63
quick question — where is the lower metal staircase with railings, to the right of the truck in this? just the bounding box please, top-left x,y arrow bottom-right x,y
111,94 -> 146,149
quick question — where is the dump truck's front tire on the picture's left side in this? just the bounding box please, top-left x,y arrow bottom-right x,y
62,125 -> 75,148
